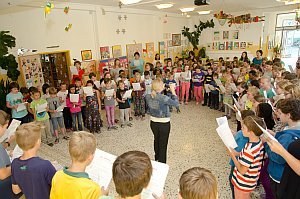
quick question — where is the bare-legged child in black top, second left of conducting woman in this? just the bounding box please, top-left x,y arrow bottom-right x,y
116,80 -> 132,128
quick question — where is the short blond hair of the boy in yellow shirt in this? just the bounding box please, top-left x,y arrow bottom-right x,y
69,131 -> 96,162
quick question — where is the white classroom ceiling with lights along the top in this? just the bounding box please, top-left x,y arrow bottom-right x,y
0,0 -> 298,15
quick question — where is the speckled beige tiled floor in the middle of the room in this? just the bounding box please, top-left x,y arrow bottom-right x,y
40,102 -> 258,199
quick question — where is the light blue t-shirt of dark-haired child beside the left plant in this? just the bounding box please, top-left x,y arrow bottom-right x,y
6,92 -> 28,118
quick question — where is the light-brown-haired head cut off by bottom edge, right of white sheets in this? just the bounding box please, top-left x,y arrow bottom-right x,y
179,167 -> 218,199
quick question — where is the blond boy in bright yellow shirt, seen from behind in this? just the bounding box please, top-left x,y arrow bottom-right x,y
50,131 -> 101,199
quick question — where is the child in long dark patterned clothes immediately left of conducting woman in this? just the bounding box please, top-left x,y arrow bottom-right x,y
133,72 -> 146,120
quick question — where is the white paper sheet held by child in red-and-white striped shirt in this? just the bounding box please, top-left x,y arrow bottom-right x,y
216,123 -> 237,149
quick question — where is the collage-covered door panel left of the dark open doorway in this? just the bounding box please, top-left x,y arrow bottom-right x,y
19,55 -> 44,88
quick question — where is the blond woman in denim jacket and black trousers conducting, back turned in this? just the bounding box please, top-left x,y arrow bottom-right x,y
145,78 -> 179,163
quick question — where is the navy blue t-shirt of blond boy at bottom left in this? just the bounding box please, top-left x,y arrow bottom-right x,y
11,157 -> 56,199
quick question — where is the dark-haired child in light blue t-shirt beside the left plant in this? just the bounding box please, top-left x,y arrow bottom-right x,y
6,82 -> 29,124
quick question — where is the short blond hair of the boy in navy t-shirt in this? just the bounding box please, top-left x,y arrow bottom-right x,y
15,122 -> 42,151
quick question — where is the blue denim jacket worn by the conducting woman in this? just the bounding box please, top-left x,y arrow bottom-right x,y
145,93 -> 179,118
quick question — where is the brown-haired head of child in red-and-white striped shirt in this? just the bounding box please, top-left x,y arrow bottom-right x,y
242,116 -> 266,137
